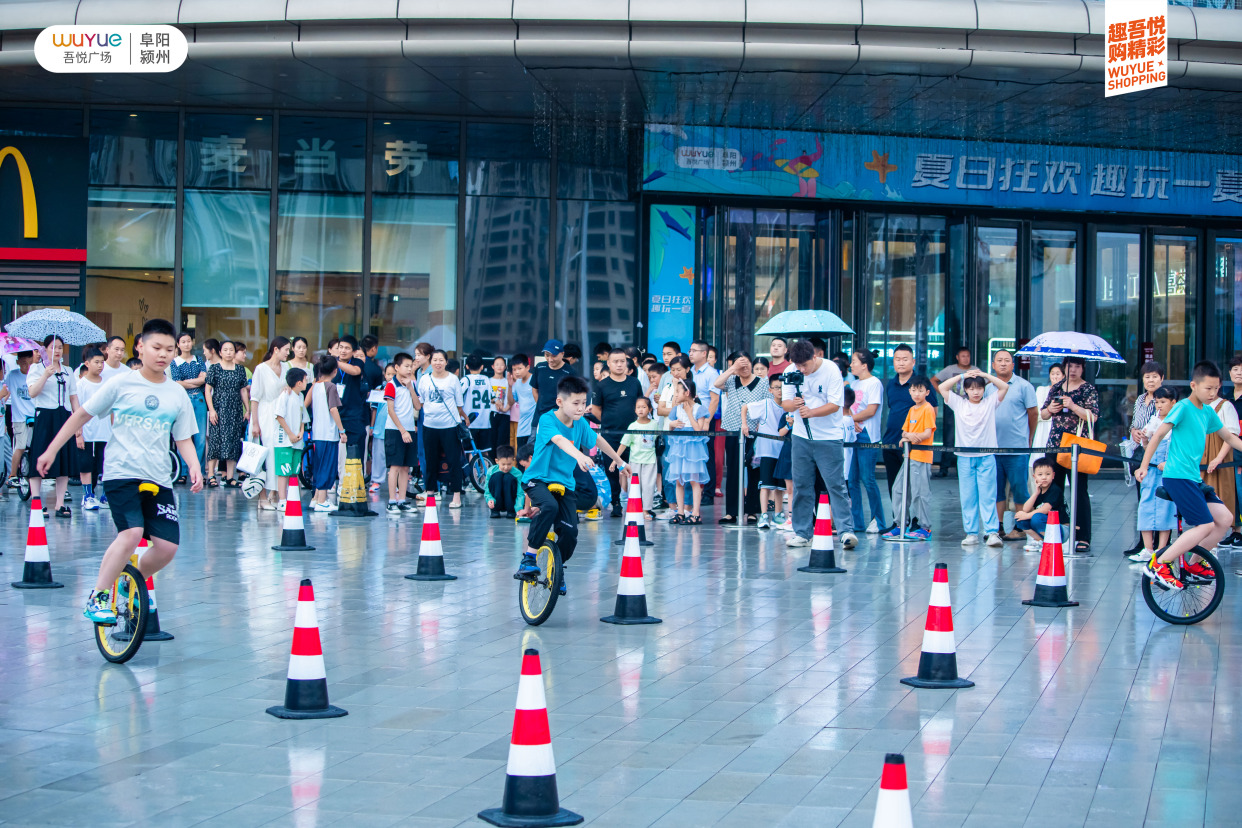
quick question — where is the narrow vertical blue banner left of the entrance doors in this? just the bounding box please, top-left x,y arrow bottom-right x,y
647,204 -> 694,354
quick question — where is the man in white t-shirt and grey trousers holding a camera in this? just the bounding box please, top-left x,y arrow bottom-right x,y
781,339 -> 858,549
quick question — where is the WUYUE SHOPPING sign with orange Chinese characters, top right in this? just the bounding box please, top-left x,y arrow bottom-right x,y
1104,0 -> 1169,98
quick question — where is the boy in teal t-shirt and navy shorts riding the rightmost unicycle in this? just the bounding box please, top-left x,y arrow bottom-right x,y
1134,361 -> 1242,590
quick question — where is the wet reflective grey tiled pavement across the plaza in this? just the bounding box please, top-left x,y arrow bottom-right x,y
0,479 -> 1242,828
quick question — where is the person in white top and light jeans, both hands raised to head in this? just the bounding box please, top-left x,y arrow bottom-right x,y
940,367 -> 1009,546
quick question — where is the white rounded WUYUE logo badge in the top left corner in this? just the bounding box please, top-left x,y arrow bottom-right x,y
35,26 -> 190,72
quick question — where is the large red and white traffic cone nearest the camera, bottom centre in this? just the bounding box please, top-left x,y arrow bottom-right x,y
478,649 -> 582,828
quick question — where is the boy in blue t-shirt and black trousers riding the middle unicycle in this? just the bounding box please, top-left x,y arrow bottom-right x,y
513,375 -> 625,595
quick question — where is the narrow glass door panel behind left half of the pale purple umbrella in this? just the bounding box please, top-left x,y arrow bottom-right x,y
1028,227 -> 1078,374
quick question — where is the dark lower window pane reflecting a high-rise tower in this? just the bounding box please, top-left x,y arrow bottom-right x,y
461,197 -> 549,356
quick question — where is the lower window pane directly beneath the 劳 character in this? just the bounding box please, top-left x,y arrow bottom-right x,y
368,196 -> 457,359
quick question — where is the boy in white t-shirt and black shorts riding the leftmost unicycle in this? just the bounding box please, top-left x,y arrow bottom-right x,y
37,319 -> 202,624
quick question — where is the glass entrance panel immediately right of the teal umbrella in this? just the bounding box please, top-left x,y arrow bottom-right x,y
862,215 -> 951,376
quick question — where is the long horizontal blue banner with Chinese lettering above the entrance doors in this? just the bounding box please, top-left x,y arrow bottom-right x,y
642,124 -> 1242,216
